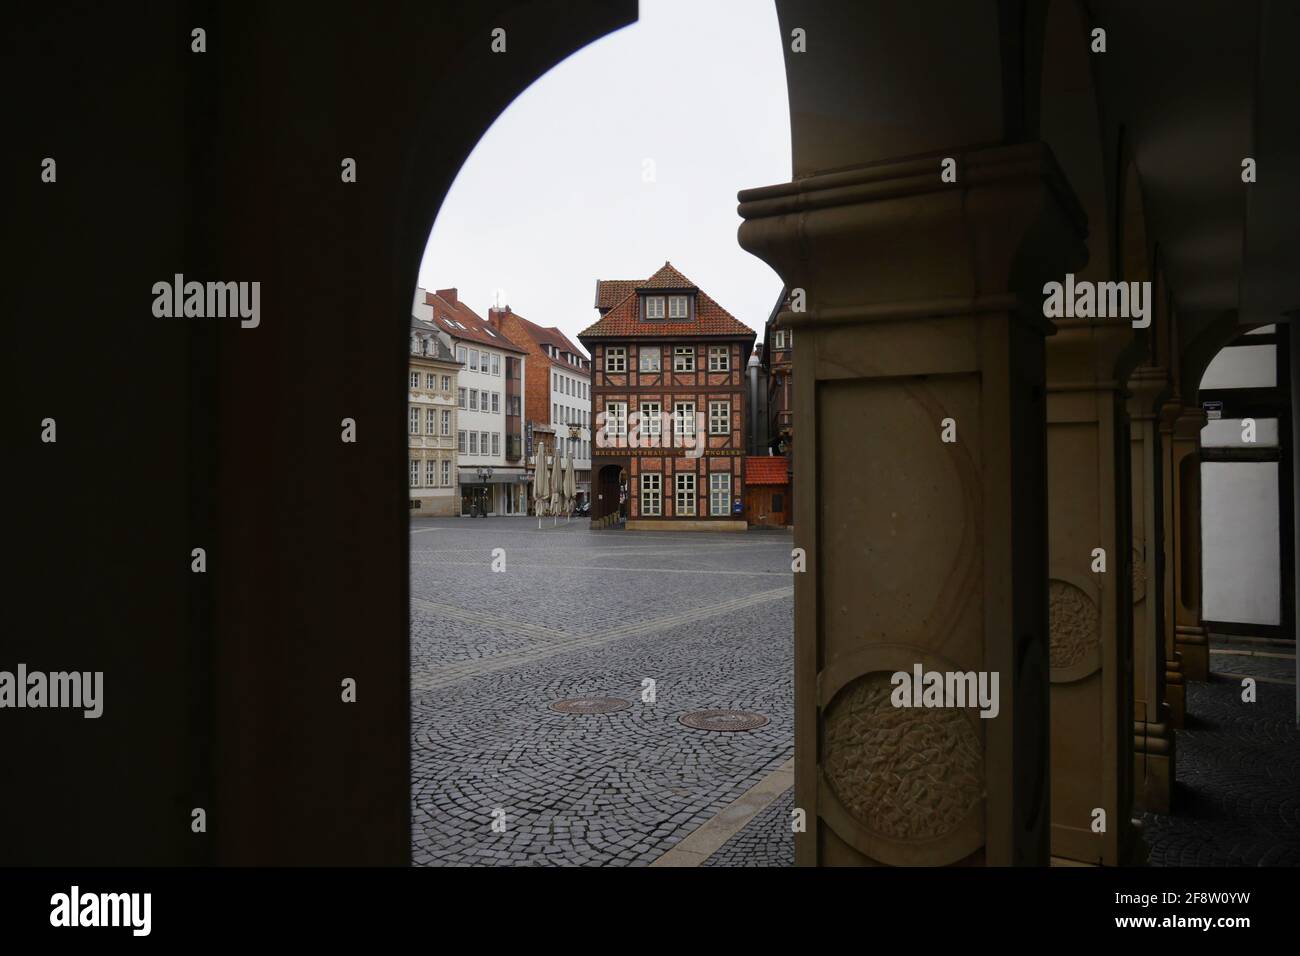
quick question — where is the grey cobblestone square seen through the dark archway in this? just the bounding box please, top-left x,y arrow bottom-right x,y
411,518 -> 793,866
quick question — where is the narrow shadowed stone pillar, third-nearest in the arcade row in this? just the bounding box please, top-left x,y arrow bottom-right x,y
1128,365 -> 1174,813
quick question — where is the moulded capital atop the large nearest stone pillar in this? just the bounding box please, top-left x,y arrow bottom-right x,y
740,143 -> 1087,323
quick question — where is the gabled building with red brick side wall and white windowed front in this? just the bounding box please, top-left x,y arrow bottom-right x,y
488,306 -> 592,501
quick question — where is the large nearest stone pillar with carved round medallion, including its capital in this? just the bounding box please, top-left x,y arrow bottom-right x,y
740,143 -> 1084,865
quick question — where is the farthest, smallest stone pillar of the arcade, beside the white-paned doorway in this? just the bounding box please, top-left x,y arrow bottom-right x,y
1171,405 -> 1210,680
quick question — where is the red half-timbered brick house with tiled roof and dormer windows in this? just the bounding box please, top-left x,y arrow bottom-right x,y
579,263 -> 755,531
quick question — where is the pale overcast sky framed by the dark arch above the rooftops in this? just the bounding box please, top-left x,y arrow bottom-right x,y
420,0 -> 790,356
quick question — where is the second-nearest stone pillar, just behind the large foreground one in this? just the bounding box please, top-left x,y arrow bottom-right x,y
1047,310 -> 1134,866
